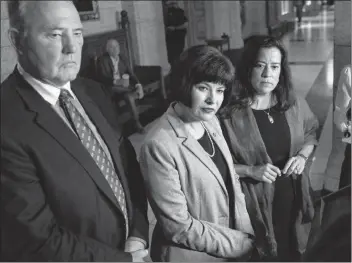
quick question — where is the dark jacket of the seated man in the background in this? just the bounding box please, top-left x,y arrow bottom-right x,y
97,53 -> 139,87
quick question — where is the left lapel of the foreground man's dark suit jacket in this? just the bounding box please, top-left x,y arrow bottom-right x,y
15,72 -> 126,214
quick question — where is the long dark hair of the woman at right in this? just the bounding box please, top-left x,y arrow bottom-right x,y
229,35 -> 295,111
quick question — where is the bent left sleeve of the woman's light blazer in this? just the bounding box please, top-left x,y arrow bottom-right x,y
140,140 -> 252,258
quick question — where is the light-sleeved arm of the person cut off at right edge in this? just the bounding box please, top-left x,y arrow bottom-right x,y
334,67 -> 351,132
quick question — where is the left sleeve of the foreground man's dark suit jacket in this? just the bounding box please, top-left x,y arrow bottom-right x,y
0,136 -> 132,261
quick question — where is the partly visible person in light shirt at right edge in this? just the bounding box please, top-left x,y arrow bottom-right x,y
334,65 -> 351,188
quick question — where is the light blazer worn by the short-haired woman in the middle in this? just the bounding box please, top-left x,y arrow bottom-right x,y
140,105 -> 253,261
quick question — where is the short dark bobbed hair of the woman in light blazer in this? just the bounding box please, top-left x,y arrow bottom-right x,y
169,45 -> 235,107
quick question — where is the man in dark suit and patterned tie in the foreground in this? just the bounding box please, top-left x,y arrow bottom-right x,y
0,1 -> 148,262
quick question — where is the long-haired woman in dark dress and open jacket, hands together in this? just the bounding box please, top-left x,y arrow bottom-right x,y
222,36 -> 318,261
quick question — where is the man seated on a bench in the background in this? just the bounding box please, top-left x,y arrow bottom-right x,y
96,39 -> 145,133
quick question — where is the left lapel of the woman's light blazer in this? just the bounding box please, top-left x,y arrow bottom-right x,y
168,106 -> 228,196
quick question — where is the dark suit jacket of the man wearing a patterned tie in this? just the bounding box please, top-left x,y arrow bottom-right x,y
0,70 -> 148,261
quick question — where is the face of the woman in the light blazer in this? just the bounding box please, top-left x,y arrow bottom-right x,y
190,82 -> 225,121
